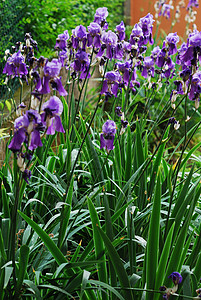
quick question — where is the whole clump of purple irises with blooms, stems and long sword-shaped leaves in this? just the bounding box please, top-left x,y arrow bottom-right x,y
0,1 -> 201,300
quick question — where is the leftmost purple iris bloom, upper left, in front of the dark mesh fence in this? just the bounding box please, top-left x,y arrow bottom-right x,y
3,50 -> 28,77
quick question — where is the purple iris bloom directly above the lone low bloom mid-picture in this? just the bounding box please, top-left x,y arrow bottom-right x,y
101,71 -> 121,97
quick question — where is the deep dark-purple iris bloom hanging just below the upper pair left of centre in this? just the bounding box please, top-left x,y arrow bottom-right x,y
72,51 -> 91,79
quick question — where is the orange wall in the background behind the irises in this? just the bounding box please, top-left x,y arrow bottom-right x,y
130,0 -> 201,38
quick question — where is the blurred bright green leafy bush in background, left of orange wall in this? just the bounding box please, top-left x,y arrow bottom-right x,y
21,0 -> 123,57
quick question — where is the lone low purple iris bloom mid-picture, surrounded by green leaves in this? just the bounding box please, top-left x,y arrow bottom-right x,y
100,120 -> 116,151
